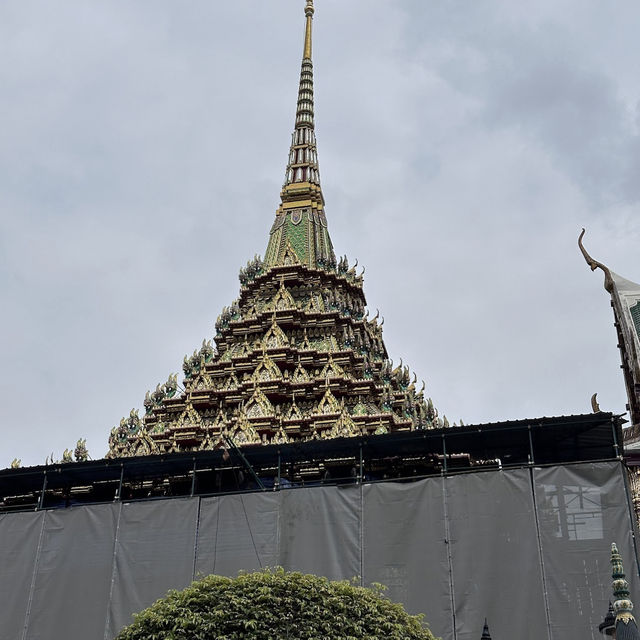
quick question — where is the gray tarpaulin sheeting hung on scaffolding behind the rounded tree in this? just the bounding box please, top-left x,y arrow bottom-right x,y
0,462 -> 640,640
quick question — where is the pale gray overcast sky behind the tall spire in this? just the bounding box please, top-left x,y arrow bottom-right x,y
0,0 -> 640,467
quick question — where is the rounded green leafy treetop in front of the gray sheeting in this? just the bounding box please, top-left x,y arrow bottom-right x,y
116,569 -> 435,640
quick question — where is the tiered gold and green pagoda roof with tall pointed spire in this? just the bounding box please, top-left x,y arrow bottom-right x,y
108,0 -> 443,457
